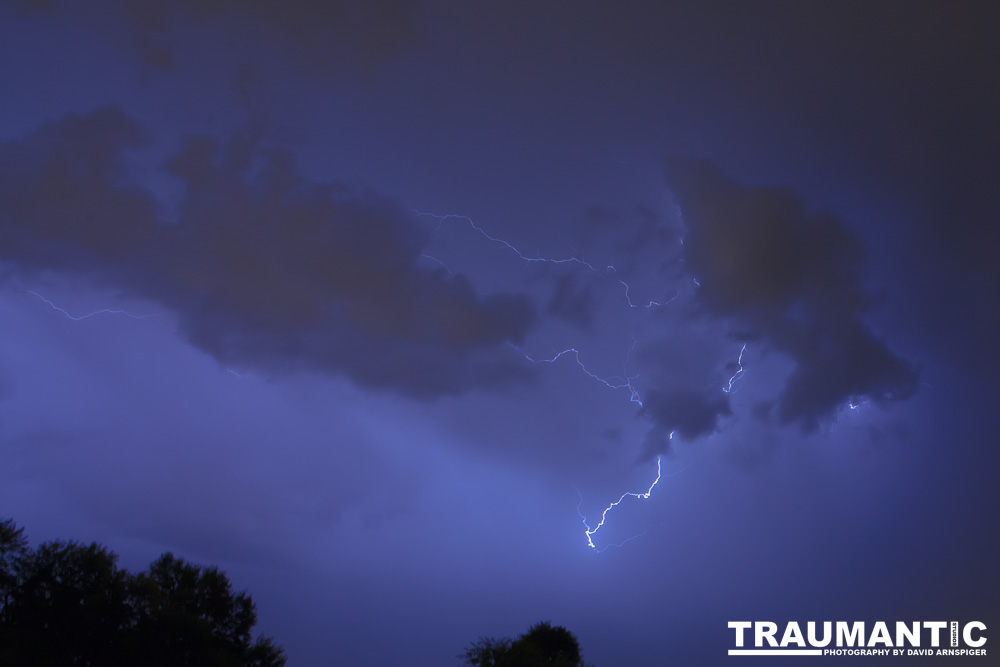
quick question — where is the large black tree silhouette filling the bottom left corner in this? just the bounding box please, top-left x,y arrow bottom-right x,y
0,520 -> 285,667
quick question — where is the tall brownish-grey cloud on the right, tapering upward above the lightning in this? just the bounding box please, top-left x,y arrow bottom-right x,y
666,158 -> 918,431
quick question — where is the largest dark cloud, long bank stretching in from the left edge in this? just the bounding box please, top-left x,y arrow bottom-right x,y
0,108 -> 536,396
